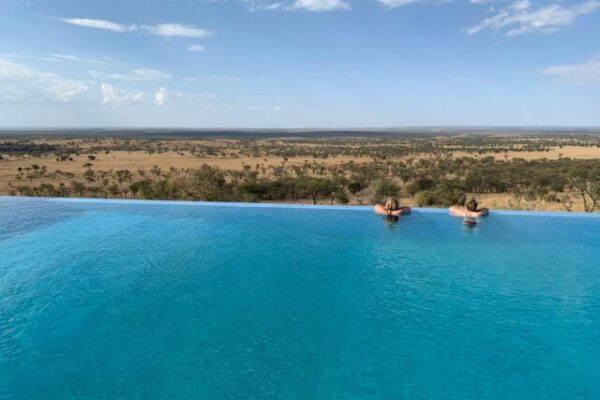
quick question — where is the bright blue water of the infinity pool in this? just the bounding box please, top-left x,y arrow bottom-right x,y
0,198 -> 600,400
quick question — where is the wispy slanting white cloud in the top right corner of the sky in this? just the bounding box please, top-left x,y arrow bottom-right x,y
465,0 -> 600,36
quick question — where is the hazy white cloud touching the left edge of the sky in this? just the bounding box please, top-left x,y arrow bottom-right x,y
0,58 -> 88,103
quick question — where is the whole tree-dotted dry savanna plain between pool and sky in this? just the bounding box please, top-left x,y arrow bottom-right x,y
0,132 -> 600,212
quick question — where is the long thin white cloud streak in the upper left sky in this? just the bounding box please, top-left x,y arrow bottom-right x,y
61,18 -> 213,38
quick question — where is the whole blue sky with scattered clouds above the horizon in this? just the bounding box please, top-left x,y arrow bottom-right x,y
0,0 -> 600,128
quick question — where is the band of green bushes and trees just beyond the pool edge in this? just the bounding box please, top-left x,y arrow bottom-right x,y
11,155 -> 600,212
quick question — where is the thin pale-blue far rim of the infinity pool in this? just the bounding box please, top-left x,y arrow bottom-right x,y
0,196 -> 600,218
